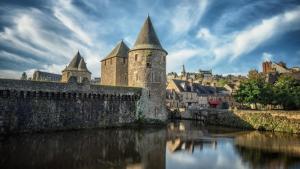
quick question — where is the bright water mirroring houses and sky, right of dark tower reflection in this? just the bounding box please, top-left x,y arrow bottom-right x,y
166,121 -> 300,169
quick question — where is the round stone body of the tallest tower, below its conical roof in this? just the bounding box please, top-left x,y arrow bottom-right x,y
128,49 -> 167,120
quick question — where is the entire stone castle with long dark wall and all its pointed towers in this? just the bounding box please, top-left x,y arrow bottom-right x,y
0,16 -> 167,134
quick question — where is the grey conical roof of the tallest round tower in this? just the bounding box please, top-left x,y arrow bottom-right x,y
132,16 -> 164,50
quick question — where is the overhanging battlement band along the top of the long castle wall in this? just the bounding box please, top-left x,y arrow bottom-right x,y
0,79 -> 142,101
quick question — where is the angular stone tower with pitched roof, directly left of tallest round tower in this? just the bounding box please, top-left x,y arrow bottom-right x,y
101,40 -> 129,86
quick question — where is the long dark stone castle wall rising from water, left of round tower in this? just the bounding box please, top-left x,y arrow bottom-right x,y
0,79 -> 142,133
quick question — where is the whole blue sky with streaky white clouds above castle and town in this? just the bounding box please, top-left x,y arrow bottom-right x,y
0,0 -> 300,78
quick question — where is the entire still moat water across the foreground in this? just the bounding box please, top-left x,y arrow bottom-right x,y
0,121 -> 300,169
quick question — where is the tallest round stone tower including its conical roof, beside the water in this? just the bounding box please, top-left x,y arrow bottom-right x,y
128,16 -> 168,120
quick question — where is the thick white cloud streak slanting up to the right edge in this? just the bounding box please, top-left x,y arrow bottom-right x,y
213,7 -> 300,60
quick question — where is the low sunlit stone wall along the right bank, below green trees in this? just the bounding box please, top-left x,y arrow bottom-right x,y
206,109 -> 300,133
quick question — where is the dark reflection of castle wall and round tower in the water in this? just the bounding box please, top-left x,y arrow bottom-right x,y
0,129 -> 165,169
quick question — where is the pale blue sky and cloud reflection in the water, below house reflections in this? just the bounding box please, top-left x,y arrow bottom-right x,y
166,139 -> 249,169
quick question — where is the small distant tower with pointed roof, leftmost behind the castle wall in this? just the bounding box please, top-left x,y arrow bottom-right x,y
61,51 -> 91,83
